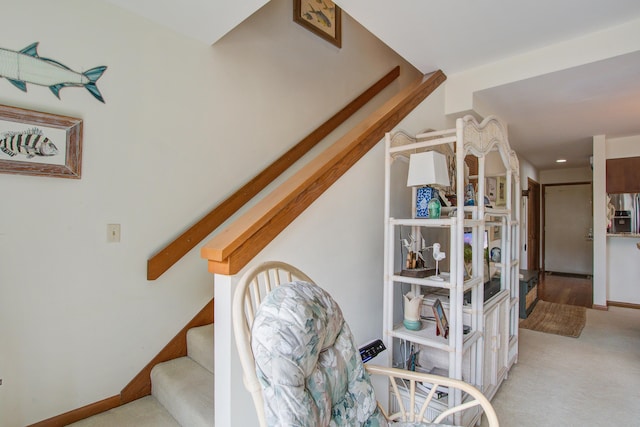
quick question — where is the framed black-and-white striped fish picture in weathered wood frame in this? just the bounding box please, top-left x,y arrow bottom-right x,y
0,105 -> 82,179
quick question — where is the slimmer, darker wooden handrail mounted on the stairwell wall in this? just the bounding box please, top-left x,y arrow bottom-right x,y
147,66 -> 400,280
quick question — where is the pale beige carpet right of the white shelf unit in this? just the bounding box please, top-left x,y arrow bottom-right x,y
482,307 -> 640,427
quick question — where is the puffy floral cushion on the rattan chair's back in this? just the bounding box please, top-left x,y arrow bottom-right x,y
251,282 -> 387,427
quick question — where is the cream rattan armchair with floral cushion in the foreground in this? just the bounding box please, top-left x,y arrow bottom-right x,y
233,261 -> 498,427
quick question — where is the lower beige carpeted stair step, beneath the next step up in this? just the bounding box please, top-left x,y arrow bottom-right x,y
151,358 -> 214,427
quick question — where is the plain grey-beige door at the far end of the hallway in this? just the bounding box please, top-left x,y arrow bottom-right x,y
544,183 -> 593,276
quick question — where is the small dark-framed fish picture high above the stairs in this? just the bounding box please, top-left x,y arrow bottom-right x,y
293,0 -> 342,47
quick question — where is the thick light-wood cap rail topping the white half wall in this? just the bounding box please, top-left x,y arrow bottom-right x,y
200,70 -> 447,275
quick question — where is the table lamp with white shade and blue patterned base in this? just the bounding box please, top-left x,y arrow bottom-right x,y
407,151 -> 450,219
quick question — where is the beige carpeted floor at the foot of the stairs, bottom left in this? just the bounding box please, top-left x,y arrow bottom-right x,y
69,396 -> 180,427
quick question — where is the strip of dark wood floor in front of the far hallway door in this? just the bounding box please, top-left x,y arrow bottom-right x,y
538,273 -> 593,308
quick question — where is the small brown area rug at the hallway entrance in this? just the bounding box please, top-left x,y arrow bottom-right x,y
520,301 -> 587,338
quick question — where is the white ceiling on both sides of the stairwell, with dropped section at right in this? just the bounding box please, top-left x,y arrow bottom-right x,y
108,0 -> 640,170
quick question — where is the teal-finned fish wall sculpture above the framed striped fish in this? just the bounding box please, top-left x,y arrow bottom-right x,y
0,42 -> 107,102
